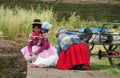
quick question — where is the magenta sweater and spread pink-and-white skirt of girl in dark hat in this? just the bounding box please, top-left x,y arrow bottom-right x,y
21,33 -> 58,66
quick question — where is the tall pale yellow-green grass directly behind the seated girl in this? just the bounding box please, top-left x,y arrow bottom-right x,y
0,6 -> 102,45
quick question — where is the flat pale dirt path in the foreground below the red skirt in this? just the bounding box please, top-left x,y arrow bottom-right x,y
27,68 -> 119,78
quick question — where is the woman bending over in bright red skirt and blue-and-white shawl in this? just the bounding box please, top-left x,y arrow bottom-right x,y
56,28 -> 90,70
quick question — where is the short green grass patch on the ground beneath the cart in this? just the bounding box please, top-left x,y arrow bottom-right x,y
90,56 -> 120,75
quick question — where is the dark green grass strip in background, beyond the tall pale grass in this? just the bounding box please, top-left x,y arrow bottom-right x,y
0,0 -> 120,22
